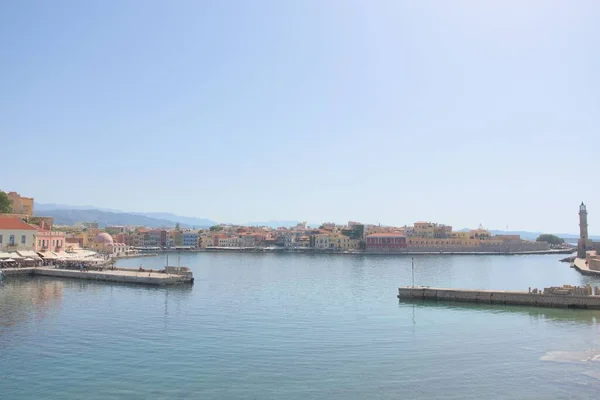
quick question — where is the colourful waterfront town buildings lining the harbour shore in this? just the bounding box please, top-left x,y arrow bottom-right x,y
0,192 -> 587,260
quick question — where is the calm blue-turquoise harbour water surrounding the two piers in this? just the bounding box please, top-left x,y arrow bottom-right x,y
0,253 -> 600,399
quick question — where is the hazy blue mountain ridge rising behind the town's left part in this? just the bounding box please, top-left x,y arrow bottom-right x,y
34,203 -> 217,229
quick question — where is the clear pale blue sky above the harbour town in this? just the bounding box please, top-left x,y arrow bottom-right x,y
0,0 -> 600,233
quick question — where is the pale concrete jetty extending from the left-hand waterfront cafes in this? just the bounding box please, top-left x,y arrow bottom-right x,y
2,267 -> 194,286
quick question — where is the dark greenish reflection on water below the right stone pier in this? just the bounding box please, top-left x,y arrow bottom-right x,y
399,299 -> 600,326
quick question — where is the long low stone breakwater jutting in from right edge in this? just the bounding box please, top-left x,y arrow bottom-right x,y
398,286 -> 600,310
